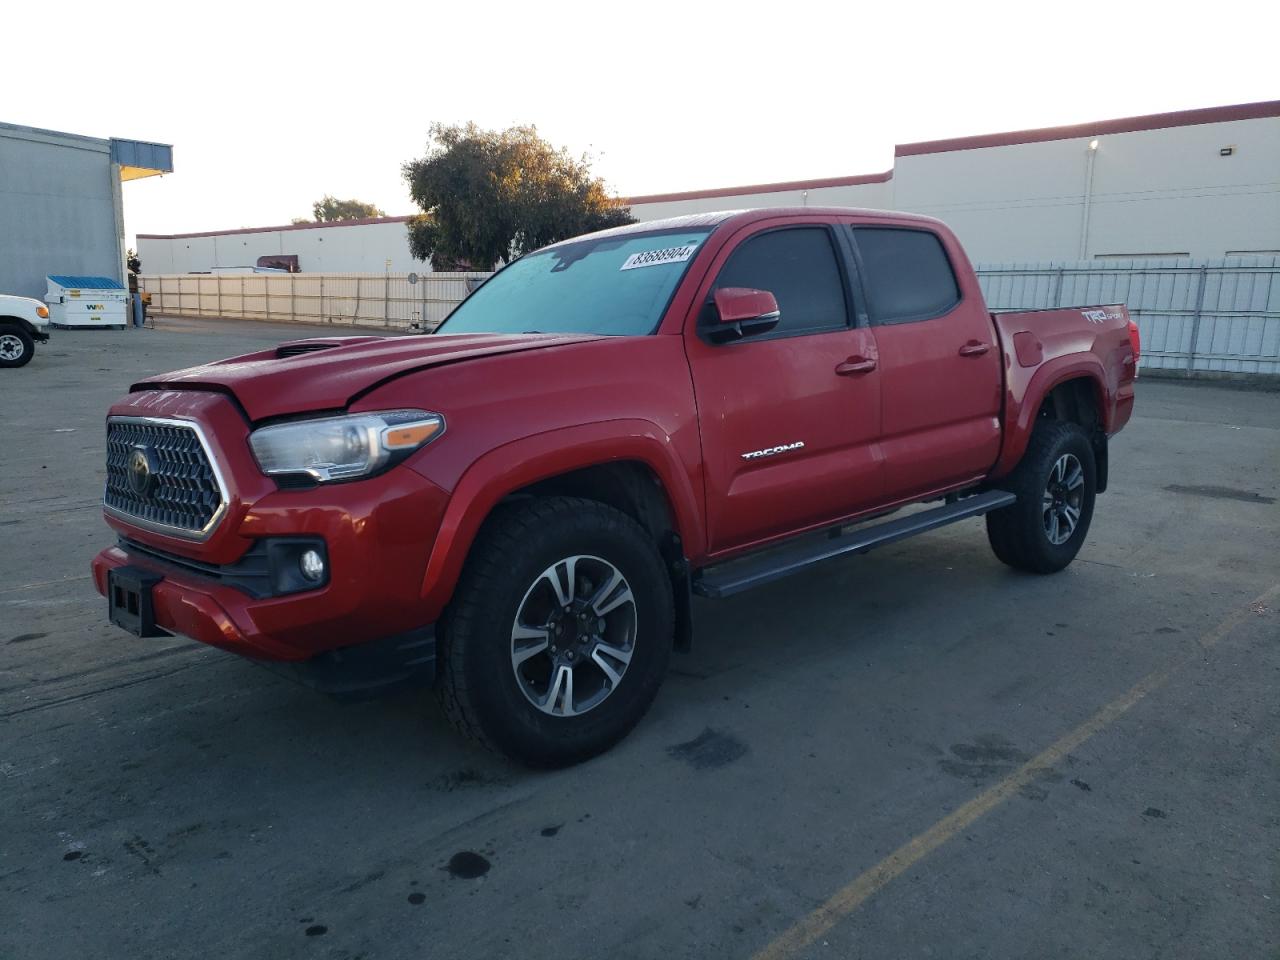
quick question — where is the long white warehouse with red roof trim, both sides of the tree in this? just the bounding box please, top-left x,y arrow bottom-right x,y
138,101 -> 1280,274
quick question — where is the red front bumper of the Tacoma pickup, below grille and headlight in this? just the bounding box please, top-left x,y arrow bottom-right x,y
92,455 -> 448,663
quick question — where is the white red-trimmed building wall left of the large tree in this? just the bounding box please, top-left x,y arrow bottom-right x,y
138,218 -> 431,274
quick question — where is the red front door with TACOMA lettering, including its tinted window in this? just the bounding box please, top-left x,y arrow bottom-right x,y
685,218 -> 883,553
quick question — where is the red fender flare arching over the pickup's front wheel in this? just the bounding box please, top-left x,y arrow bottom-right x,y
422,420 -> 704,621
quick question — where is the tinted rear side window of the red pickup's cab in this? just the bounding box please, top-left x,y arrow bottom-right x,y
854,227 -> 960,324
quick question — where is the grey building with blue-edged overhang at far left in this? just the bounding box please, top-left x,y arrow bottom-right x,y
0,123 -> 173,300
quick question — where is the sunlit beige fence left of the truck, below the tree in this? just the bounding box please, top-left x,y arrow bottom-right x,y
140,273 -> 489,330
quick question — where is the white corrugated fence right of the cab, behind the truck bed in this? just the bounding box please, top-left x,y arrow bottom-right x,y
977,256 -> 1280,375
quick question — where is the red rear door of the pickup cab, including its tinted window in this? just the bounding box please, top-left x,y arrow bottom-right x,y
850,220 -> 1004,500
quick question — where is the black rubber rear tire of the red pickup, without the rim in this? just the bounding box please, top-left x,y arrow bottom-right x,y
987,420 -> 1097,573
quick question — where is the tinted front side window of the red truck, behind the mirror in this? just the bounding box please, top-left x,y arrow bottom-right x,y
716,227 -> 849,337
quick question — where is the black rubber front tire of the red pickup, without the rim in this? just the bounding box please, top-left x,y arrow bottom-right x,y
436,497 -> 675,767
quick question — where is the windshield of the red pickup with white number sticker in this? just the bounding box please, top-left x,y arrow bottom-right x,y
436,228 -> 710,337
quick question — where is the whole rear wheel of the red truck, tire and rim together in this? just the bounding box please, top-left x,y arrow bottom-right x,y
987,420 -> 1096,573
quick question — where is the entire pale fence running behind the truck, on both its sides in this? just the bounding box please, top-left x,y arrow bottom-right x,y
141,256 -> 1280,375
